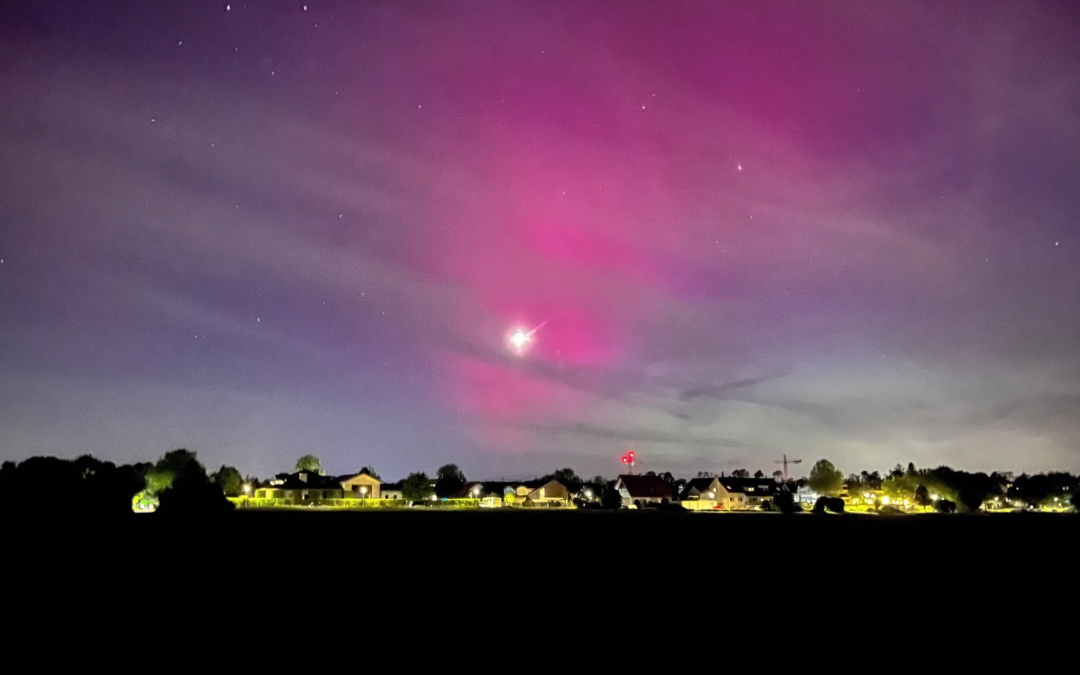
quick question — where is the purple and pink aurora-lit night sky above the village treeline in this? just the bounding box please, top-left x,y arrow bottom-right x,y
0,0 -> 1080,480
